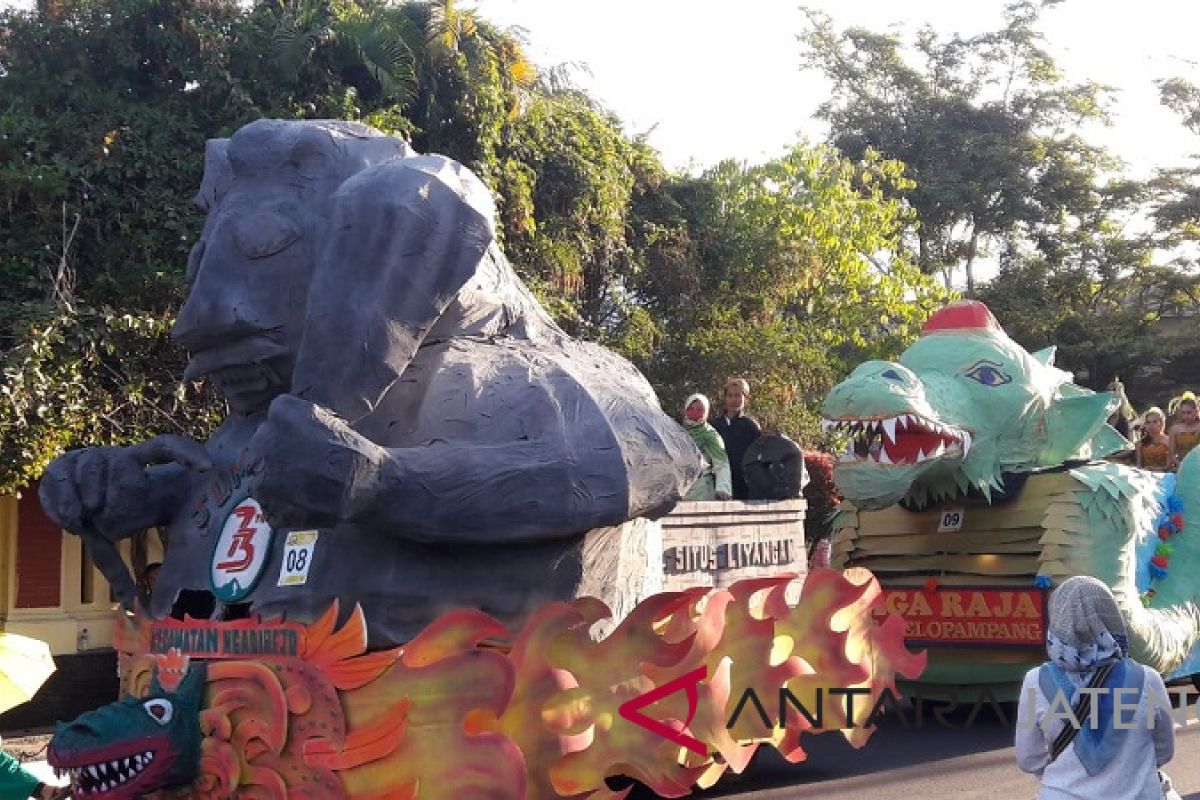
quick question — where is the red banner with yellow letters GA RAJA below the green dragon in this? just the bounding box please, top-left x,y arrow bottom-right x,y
871,587 -> 1046,648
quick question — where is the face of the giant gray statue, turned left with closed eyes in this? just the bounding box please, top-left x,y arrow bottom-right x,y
174,120 -> 409,413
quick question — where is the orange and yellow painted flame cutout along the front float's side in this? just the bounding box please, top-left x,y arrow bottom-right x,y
114,570 -> 925,800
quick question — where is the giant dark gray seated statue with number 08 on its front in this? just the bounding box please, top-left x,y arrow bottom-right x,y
41,120 -> 700,644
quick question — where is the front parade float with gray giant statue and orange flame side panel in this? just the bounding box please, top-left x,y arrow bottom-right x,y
40,120 -> 924,800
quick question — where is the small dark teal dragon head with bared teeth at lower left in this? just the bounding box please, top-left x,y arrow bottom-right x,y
47,663 -> 206,800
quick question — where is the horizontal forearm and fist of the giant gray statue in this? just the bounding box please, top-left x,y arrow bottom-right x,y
252,396 -> 638,542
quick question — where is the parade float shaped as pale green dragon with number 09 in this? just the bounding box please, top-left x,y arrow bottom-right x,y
822,301 -> 1200,697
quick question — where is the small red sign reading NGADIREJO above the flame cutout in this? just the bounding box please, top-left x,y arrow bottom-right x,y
150,620 -> 305,658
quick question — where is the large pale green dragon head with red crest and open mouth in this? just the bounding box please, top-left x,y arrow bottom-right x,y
822,301 -> 1128,509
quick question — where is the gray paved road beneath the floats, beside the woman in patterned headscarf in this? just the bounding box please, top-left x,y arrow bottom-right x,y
632,694 -> 1200,800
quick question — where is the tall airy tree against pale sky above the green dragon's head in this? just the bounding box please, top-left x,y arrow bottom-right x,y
800,0 -> 1115,295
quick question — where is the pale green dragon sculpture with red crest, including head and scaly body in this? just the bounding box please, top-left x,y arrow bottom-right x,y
822,301 -> 1200,676
